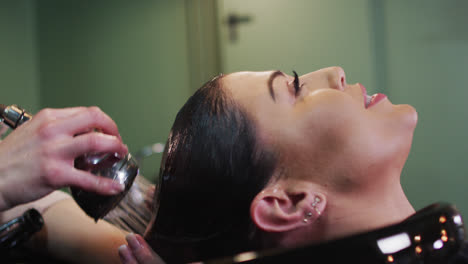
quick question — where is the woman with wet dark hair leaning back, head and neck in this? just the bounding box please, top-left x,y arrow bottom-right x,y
121,67 -> 417,263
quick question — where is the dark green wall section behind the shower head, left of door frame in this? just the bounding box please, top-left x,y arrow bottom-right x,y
37,0 -> 191,178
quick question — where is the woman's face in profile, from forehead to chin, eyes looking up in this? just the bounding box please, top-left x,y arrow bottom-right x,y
222,67 -> 417,191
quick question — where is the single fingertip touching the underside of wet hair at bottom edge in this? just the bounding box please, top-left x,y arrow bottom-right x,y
125,234 -> 164,264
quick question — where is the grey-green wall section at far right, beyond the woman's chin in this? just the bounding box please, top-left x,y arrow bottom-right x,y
382,0 -> 468,219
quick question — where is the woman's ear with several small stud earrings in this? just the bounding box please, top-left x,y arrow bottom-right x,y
250,184 -> 326,232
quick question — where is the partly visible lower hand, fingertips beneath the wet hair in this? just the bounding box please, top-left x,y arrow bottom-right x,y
119,234 -> 164,264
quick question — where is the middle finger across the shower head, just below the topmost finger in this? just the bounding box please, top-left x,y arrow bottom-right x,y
57,132 -> 128,158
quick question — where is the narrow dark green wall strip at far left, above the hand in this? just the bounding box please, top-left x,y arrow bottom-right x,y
0,0 -> 39,112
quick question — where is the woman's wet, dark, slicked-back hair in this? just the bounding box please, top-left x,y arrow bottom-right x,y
145,77 -> 276,263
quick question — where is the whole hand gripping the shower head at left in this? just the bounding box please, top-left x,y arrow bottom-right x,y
0,107 -> 128,211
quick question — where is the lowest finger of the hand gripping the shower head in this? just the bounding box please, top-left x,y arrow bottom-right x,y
47,165 -> 125,195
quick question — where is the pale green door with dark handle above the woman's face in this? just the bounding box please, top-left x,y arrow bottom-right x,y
218,0 -> 377,92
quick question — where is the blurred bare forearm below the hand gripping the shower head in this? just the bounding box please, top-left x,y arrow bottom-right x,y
29,199 -> 126,263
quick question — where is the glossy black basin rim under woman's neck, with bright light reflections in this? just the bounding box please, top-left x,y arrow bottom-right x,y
203,202 -> 465,264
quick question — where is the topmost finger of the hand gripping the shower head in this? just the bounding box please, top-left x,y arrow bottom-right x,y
50,107 -> 120,138
